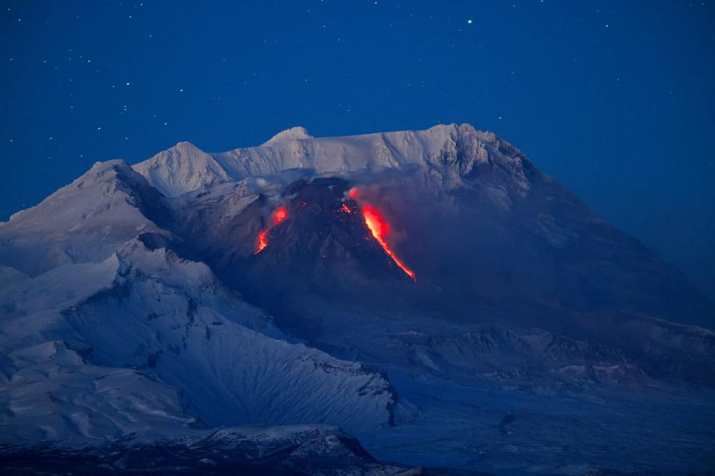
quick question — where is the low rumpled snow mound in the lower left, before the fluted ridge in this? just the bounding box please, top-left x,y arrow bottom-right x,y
0,341 -> 195,444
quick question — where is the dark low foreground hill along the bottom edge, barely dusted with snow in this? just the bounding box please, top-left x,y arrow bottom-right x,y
0,426 -> 425,476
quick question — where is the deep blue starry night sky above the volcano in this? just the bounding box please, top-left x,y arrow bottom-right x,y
0,0 -> 715,295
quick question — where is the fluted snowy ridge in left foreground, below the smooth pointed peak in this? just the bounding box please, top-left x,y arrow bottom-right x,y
0,240 -> 395,441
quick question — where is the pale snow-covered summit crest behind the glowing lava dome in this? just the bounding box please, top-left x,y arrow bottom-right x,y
134,124 -> 529,197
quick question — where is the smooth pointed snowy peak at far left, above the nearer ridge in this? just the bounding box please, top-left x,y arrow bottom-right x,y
0,160 -> 171,276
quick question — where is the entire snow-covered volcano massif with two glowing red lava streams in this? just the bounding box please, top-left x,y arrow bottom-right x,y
0,124 -> 715,474
